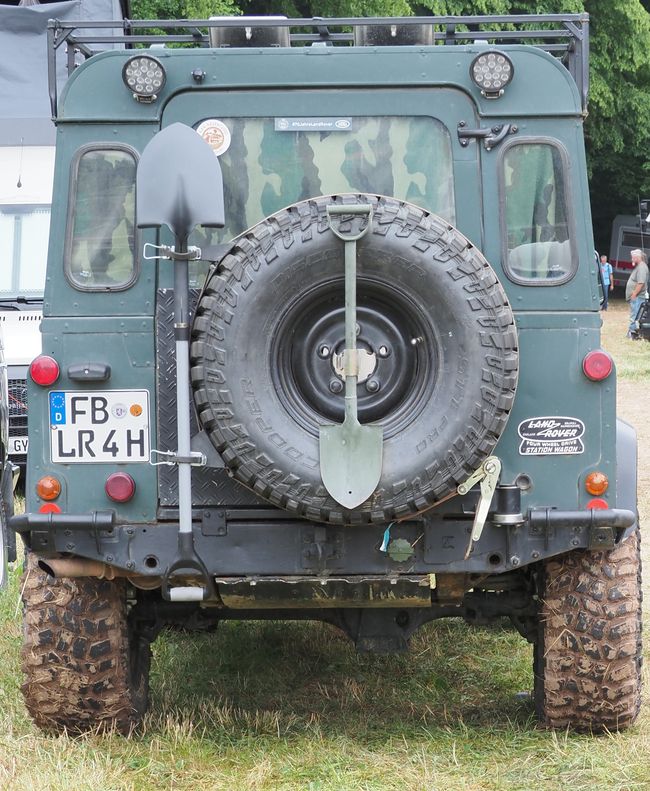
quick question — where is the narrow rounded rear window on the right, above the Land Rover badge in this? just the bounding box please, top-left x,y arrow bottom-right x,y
501,142 -> 575,285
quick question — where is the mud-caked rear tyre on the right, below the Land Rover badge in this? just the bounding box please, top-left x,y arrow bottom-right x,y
534,531 -> 642,733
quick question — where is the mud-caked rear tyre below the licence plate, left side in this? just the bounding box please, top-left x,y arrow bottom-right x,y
22,553 -> 150,734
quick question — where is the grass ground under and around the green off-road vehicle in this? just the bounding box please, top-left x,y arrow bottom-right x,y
0,302 -> 650,791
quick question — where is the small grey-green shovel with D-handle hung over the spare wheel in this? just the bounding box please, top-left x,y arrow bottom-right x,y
320,205 -> 384,508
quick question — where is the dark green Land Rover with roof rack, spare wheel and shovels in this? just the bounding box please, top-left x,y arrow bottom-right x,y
11,15 -> 641,731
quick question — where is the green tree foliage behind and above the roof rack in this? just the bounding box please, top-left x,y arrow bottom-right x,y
131,0 -> 650,251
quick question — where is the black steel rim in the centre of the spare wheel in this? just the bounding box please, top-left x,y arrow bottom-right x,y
272,281 -> 436,430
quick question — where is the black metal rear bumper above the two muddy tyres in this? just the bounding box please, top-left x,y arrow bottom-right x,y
9,508 -> 636,577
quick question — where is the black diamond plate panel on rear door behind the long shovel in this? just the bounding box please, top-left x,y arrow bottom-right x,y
156,288 -> 268,506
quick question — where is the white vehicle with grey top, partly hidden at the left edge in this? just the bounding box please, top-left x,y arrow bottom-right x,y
0,0 -> 129,467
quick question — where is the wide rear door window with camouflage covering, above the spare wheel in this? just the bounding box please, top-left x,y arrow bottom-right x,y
191,116 -> 456,285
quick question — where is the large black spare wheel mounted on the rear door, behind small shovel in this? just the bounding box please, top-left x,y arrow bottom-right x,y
191,194 -> 518,524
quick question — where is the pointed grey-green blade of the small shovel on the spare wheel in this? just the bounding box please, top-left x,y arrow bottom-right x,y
320,418 -> 384,508
